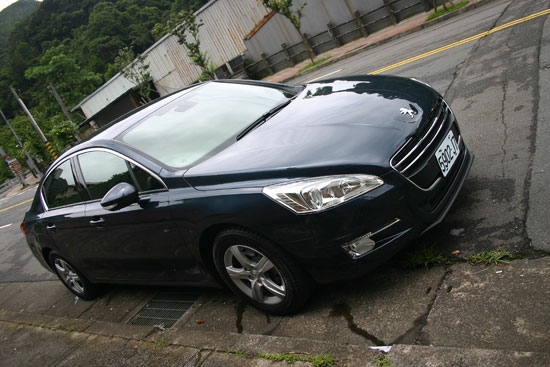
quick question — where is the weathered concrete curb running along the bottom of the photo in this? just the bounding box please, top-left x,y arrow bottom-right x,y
0,311 -> 550,367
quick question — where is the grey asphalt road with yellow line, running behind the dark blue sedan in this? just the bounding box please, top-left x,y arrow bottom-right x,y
0,0 -> 550,310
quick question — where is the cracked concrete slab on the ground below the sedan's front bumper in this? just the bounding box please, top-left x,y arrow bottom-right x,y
273,267 -> 445,346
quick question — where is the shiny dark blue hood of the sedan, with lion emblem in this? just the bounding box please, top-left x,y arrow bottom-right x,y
185,76 -> 437,187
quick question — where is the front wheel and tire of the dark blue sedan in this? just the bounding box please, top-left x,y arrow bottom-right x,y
213,229 -> 313,315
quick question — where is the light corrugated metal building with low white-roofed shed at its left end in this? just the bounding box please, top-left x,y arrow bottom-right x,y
73,0 -> 269,130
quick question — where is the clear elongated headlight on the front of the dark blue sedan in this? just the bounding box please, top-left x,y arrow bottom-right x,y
263,174 -> 384,214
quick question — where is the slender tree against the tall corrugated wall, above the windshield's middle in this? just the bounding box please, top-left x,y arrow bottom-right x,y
157,10 -> 216,80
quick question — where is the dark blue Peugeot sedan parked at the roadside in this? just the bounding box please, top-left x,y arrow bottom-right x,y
21,76 -> 473,314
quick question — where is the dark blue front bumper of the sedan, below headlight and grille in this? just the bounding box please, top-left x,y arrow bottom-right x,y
260,145 -> 473,283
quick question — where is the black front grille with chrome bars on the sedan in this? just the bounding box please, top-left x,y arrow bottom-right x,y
390,98 -> 461,190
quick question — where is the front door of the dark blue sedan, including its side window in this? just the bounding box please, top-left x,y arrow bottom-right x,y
73,150 -> 187,283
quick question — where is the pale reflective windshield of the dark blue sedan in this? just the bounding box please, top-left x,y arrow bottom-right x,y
120,82 -> 292,168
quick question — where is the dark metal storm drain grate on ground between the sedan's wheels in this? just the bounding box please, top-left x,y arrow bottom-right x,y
129,291 -> 201,328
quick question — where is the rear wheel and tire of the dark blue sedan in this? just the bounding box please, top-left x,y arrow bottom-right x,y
49,252 -> 99,300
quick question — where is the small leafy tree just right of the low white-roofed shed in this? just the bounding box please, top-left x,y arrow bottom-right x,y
115,47 -> 151,103
